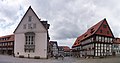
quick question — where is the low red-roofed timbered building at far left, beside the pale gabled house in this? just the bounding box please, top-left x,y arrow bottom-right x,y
0,34 -> 14,55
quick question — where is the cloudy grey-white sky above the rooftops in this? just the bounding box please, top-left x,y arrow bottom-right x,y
0,0 -> 120,47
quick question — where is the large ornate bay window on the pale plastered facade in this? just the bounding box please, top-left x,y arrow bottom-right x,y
24,32 -> 35,52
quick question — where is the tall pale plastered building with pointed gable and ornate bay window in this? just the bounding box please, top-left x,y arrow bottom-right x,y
14,6 -> 50,58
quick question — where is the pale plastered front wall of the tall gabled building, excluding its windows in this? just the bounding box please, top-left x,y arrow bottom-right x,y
14,7 -> 47,58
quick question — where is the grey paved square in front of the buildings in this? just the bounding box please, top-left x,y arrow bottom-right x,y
0,55 -> 120,63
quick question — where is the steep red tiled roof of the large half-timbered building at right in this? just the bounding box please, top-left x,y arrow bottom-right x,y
72,19 -> 114,47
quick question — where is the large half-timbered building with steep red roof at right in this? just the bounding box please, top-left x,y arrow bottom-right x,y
72,19 -> 114,57
